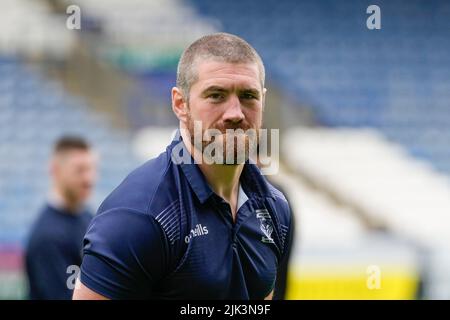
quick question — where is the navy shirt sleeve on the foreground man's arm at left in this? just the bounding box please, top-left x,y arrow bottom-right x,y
80,208 -> 169,299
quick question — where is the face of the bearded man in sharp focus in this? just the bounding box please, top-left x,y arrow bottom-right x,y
186,60 -> 264,159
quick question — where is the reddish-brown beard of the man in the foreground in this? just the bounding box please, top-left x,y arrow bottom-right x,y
187,113 -> 260,165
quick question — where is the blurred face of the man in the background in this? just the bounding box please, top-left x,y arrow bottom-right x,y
53,149 -> 97,208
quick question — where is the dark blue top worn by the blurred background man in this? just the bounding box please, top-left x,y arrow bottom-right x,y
25,205 -> 92,300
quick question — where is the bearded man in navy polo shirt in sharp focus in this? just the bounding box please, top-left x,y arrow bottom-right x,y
74,33 -> 292,299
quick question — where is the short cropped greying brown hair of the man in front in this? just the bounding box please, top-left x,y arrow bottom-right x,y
177,32 -> 265,99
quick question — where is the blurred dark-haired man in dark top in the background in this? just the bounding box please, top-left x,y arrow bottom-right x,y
25,136 -> 96,299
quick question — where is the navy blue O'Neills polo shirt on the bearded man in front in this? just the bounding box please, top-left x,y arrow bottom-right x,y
80,135 -> 291,299
